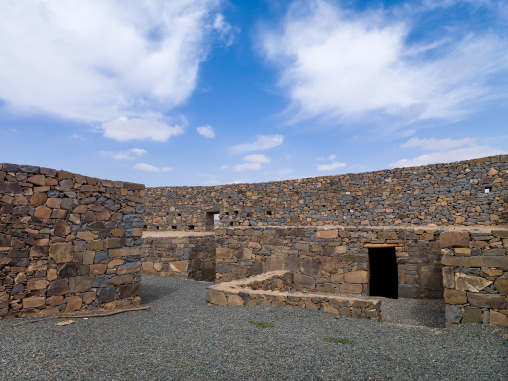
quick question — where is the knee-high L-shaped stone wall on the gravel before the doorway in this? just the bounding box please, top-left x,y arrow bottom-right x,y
206,271 -> 381,321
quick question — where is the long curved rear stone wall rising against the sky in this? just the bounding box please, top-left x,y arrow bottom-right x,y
145,155 -> 508,231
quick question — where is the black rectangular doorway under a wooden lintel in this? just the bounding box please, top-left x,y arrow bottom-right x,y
369,247 -> 399,299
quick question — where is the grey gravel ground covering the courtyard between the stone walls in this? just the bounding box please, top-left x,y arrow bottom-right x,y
0,276 -> 508,380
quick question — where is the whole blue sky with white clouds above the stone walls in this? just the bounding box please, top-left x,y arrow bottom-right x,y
0,0 -> 508,186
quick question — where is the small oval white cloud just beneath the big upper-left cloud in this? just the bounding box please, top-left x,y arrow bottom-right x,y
102,117 -> 184,142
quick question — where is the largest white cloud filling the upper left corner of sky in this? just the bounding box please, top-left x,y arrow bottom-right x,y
0,0 -> 222,122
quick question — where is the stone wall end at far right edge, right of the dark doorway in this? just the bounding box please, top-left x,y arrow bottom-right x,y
441,229 -> 508,326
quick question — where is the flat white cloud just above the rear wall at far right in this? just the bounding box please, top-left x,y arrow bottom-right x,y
391,138 -> 506,167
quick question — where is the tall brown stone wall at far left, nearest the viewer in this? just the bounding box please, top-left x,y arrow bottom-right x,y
0,164 -> 145,318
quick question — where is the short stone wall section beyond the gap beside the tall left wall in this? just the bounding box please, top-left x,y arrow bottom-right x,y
141,232 -> 215,281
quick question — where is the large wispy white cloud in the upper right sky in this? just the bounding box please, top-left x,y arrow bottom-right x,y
262,0 -> 508,122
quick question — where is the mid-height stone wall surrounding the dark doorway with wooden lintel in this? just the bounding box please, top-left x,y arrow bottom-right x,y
212,226 -> 443,298
